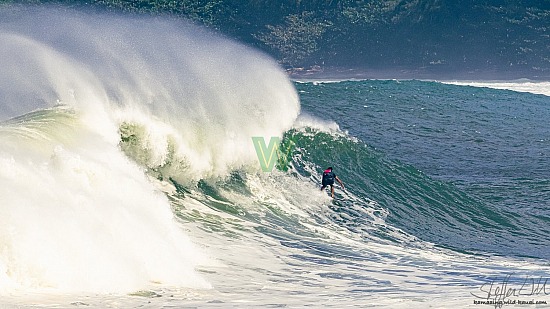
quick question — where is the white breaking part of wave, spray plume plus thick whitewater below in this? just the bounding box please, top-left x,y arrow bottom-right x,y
0,8 -> 299,291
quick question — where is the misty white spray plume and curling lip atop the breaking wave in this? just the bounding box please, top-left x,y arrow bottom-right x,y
0,5 -> 300,180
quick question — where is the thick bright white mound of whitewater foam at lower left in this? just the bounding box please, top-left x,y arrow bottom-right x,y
0,110 -> 209,292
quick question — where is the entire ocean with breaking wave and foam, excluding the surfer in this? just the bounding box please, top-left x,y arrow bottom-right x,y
0,8 -> 550,308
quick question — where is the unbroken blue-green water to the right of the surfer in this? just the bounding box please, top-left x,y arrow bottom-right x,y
297,81 -> 550,258
